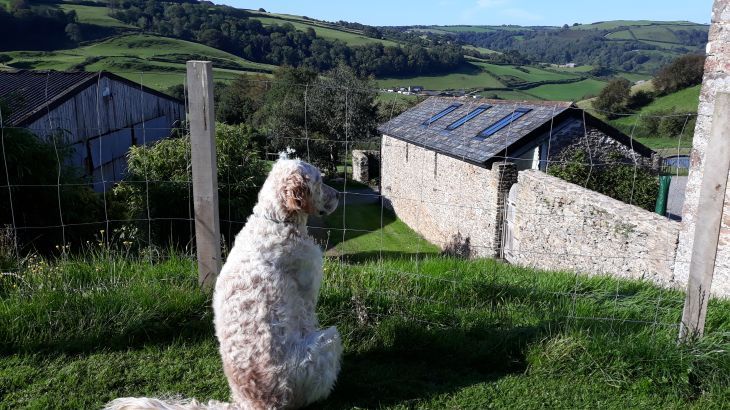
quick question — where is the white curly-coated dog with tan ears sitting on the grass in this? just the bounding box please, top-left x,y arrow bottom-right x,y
106,159 -> 342,410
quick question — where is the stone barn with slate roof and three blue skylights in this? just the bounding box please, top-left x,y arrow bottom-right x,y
379,97 -> 659,257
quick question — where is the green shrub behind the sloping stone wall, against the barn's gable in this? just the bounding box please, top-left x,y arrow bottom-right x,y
548,149 -> 659,211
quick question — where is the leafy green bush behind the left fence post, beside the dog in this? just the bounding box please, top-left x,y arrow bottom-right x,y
114,124 -> 266,246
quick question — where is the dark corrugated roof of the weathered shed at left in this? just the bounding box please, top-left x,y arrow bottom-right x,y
0,70 -> 182,127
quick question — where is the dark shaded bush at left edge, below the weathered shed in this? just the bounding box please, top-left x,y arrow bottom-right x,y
0,128 -> 111,252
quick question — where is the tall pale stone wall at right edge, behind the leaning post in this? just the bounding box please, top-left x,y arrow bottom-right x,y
674,0 -> 730,296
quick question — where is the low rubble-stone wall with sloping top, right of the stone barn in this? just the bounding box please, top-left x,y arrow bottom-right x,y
507,170 -> 680,285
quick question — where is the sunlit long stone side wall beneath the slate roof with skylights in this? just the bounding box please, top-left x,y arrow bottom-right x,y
381,135 -> 516,257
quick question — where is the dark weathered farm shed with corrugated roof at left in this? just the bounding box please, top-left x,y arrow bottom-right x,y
0,70 -> 185,190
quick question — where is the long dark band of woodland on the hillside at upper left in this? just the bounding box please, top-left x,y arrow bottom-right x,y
109,0 -> 464,76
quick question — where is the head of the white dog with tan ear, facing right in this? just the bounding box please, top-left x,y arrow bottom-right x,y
267,159 -> 338,219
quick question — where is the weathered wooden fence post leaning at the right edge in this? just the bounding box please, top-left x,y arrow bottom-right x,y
679,93 -> 730,341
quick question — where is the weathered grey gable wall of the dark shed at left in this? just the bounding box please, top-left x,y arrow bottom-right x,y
23,77 -> 184,186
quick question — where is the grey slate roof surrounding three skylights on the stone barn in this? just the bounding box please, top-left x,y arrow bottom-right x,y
378,97 -> 653,165
